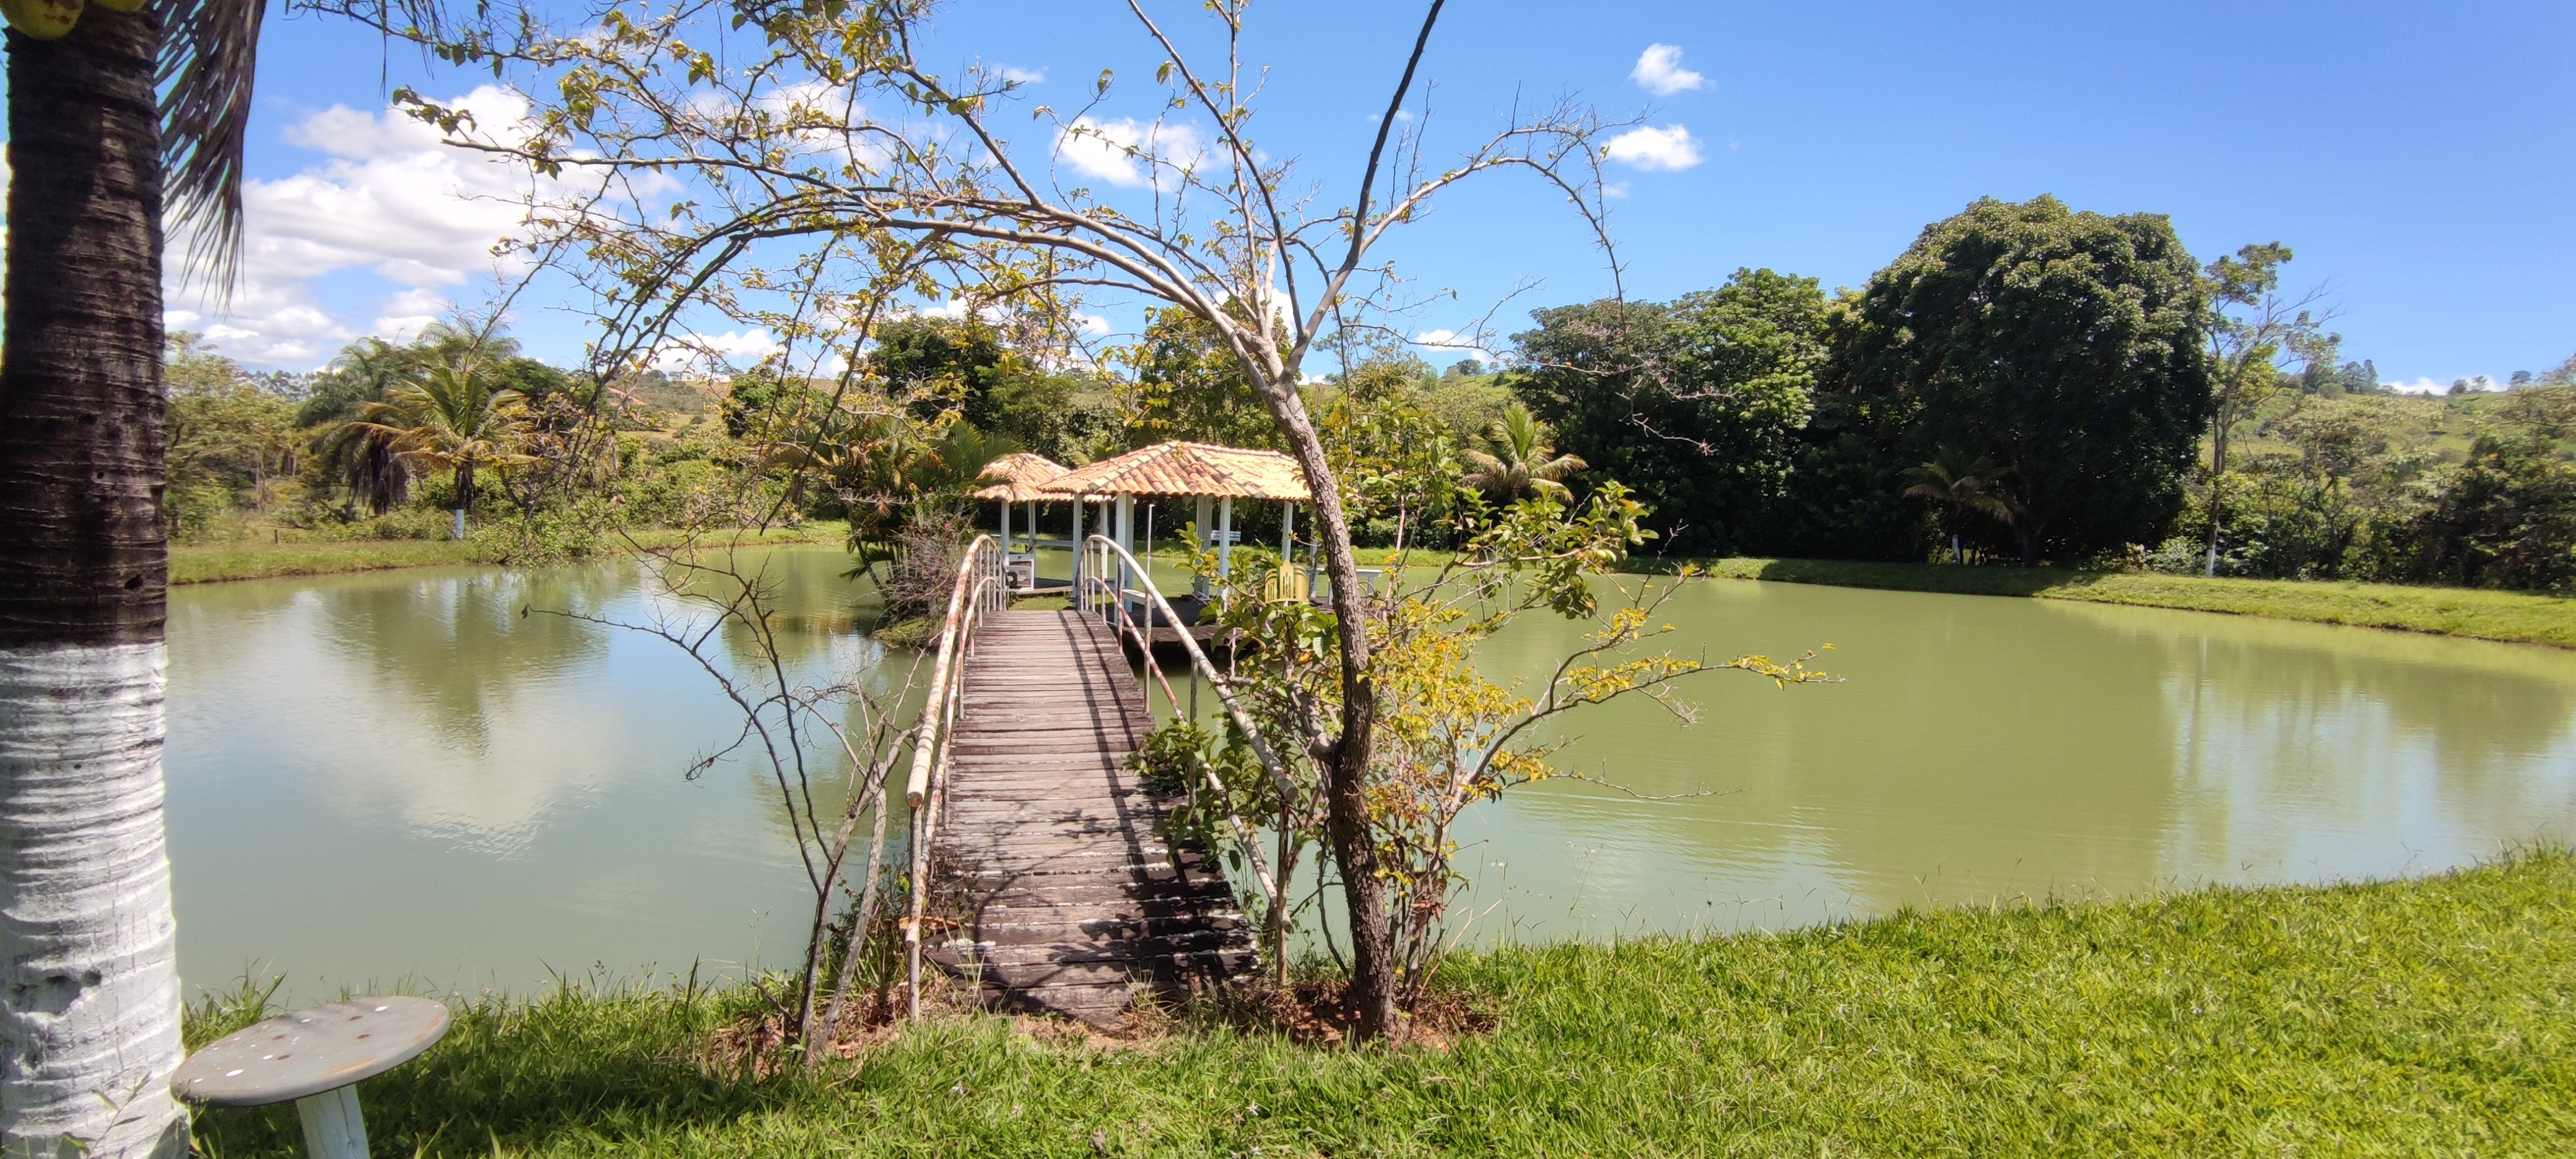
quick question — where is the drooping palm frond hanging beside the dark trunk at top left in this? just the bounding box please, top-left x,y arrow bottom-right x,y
160,0 -> 268,299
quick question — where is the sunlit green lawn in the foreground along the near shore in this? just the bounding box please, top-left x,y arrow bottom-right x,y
191,853 -> 2576,1157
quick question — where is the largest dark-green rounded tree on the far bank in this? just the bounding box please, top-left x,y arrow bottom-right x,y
1845,196 -> 2210,564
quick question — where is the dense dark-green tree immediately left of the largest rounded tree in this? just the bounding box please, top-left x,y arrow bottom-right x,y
1515,271 -> 1829,551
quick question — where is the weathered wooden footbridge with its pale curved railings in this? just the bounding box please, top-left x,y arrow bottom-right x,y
907,536 -> 1268,1023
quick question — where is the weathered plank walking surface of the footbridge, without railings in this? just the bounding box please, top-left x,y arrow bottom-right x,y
925,610 -> 1252,1023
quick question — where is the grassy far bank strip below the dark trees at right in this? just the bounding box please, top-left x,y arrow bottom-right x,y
1689,559 -> 2576,649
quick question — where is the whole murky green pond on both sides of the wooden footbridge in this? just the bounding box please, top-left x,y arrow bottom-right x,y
167,549 -> 2576,997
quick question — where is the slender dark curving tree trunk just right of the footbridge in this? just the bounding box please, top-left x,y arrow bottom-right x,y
1262,384 -> 1396,1038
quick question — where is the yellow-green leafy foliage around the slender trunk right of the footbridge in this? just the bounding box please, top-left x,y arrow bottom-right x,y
1169,482 -> 1829,1004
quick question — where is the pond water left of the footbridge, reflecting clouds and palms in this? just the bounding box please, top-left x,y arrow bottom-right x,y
170,551 -> 904,994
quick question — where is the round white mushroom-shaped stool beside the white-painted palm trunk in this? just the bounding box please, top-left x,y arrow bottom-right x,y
170,997 -> 448,1159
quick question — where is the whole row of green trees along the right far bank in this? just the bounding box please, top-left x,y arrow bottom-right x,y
1507,196 -> 2576,590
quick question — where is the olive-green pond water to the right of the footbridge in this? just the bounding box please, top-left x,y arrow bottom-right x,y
1474,582 -> 2576,937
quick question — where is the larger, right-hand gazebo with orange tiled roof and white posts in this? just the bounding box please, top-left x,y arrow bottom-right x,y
1035,440 -> 1314,607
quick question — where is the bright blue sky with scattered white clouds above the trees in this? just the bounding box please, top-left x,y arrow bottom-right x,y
136,0 -> 2576,384
